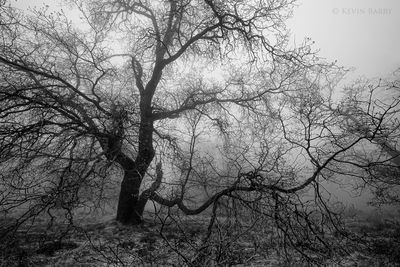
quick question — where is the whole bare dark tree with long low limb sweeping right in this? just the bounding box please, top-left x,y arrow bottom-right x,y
0,0 -> 399,264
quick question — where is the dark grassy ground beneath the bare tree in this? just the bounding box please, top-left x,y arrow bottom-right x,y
0,210 -> 400,266
